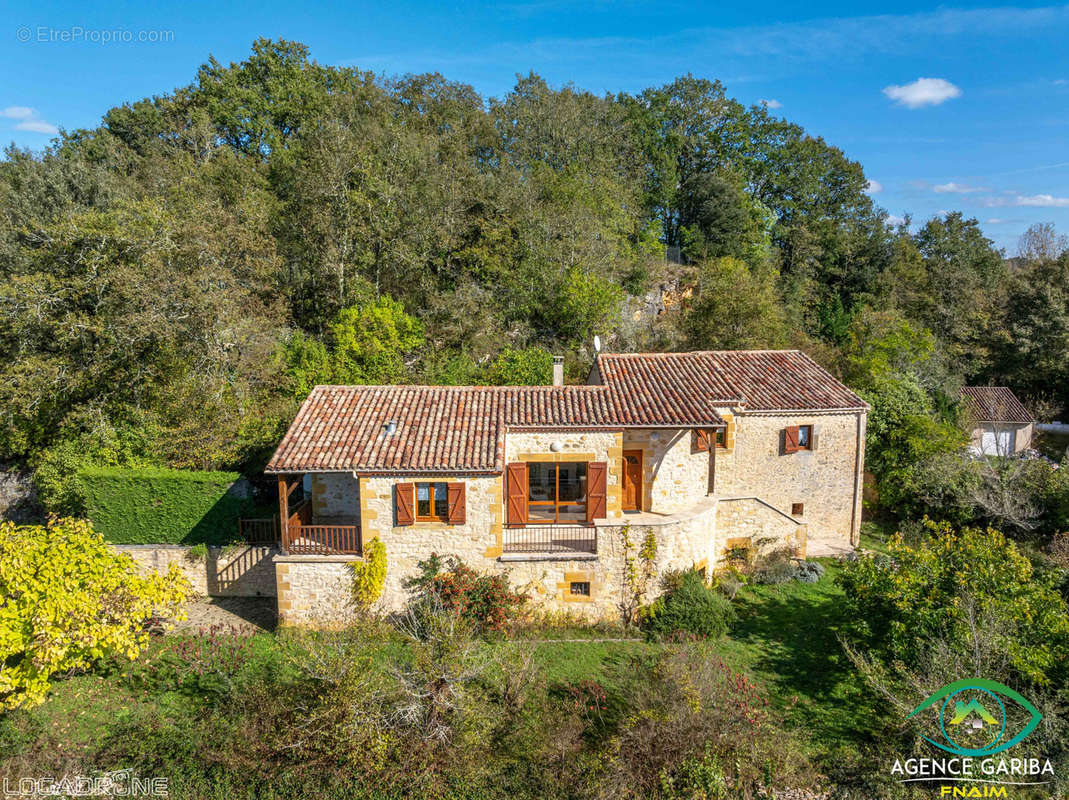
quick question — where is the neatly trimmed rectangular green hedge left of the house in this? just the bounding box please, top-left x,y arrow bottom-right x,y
79,466 -> 254,544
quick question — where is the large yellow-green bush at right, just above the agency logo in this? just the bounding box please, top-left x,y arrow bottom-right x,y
837,521 -> 1069,683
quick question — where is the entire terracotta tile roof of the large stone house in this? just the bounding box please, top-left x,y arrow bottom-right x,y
266,351 -> 866,473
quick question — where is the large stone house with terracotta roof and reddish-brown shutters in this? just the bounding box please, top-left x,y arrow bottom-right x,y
266,351 -> 868,624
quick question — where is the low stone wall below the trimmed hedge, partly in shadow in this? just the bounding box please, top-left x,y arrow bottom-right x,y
111,544 -> 279,597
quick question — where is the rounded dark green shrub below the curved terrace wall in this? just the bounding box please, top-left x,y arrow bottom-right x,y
642,570 -> 734,639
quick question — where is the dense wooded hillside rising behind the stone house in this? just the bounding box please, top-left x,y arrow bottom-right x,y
0,40 -> 1069,525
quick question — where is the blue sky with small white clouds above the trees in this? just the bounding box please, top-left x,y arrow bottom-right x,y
0,0 -> 1069,255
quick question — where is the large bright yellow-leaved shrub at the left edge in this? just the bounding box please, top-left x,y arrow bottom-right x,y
0,520 -> 190,708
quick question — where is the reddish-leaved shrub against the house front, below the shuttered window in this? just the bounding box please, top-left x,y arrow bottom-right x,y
405,553 -> 527,631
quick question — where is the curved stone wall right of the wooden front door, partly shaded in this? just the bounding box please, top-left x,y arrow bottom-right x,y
622,430 -> 709,513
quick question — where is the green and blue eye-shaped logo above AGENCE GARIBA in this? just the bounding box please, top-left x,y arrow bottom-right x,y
910,678 -> 1043,756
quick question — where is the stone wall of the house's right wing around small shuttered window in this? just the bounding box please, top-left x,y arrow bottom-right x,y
713,410 -> 865,541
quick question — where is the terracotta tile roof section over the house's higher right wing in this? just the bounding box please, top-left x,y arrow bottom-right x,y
591,350 -> 868,411
